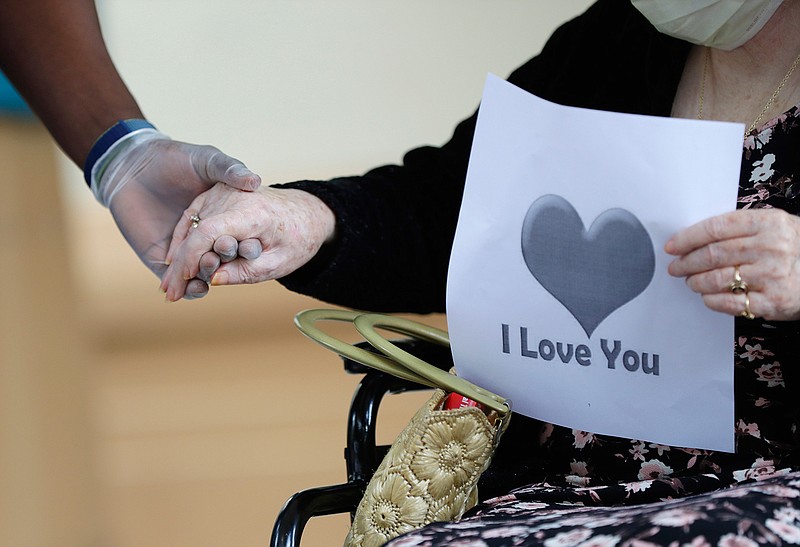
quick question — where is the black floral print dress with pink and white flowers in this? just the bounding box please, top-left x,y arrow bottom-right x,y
387,107 -> 800,547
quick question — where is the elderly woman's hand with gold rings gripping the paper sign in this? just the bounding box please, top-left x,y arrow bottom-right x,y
664,209 -> 800,321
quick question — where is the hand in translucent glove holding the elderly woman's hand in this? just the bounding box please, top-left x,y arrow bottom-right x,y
92,129 -> 261,298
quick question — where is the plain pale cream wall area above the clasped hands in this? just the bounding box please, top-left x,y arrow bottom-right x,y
59,0 -> 591,202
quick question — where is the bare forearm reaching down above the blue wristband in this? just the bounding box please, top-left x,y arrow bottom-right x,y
0,0 -> 143,166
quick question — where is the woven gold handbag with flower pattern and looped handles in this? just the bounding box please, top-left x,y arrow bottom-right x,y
295,310 -> 511,547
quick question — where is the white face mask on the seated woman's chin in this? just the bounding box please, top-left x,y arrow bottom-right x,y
631,0 -> 783,50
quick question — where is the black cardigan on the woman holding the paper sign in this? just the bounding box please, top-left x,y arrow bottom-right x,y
276,0 -> 688,313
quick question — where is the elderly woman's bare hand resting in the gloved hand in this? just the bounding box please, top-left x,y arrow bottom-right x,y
161,184 -> 336,301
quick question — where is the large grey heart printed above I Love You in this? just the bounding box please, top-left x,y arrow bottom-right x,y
522,195 -> 655,337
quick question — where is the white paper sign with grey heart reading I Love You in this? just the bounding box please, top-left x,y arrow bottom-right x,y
447,75 -> 744,452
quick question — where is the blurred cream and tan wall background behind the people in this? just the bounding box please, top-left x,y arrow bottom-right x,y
6,0 -> 590,547
